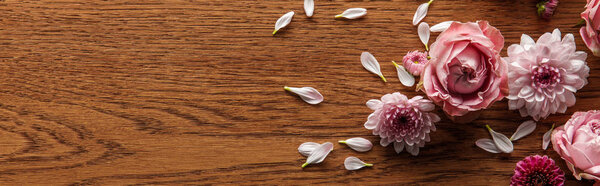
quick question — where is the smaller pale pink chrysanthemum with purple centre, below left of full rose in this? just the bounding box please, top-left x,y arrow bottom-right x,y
365,92 -> 440,156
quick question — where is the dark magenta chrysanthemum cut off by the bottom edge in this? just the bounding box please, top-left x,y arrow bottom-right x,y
510,155 -> 565,186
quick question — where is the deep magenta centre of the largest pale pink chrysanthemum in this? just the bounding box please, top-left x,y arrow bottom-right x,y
531,64 -> 560,89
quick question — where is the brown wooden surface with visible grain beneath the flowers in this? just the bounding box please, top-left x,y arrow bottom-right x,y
0,0 -> 600,185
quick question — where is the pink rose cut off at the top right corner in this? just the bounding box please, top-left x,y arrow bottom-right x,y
579,0 -> 600,56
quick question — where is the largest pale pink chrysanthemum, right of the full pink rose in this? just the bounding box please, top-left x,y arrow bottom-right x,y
505,29 -> 590,121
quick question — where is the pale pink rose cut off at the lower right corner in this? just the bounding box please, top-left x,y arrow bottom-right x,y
552,110 -> 600,182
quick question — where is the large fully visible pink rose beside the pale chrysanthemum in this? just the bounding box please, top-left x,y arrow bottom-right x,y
421,21 -> 508,116
